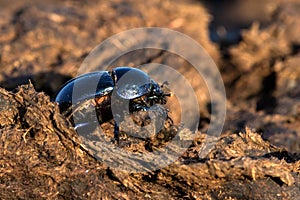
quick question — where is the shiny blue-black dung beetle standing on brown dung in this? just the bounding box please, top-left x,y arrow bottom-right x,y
55,67 -> 170,143
